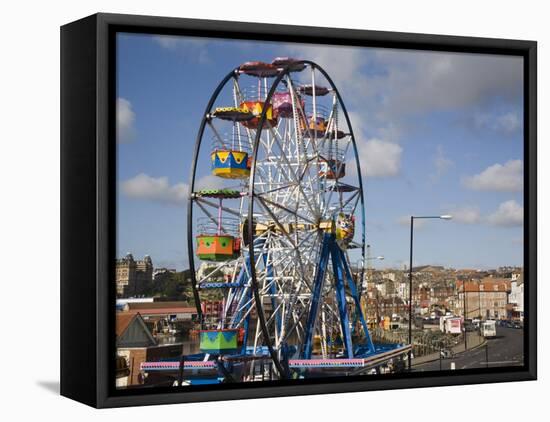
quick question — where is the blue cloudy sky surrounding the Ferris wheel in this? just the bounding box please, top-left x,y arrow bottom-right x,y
117,34 -> 524,270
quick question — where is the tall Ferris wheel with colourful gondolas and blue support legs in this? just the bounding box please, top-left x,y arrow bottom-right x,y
187,58 -> 375,378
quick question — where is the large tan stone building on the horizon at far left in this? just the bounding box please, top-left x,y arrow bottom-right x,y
116,253 -> 153,297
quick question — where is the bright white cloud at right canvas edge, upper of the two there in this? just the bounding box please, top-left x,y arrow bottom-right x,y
463,160 -> 523,192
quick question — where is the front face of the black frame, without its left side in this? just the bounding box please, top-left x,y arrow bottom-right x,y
61,13 -> 537,407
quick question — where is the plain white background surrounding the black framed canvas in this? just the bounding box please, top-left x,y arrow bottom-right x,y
0,0 -> 550,422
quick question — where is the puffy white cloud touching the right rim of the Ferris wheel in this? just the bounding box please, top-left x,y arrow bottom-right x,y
357,139 -> 403,177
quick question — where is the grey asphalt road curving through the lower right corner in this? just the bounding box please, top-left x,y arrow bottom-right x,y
413,327 -> 523,372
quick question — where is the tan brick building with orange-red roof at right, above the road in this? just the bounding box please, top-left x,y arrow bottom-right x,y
456,277 -> 510,319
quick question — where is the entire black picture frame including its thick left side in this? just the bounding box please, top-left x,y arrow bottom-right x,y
61,13 -> 537,408
